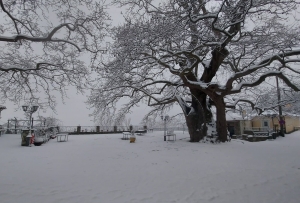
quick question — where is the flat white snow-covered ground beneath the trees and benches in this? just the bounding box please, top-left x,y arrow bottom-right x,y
0,132 -> 300,203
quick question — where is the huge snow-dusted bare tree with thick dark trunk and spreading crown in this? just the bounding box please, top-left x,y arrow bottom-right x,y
89,0 -> 300,142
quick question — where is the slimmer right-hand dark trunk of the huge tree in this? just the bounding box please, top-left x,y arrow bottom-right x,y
214,98 -> 227,142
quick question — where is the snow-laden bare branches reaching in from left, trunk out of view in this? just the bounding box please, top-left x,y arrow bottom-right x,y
0,0 -> 109,107
